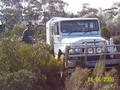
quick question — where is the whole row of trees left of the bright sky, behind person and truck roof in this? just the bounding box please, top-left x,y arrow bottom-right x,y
0,0 -> 66,27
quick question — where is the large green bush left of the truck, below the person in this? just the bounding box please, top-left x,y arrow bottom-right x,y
0,38 -> 61,90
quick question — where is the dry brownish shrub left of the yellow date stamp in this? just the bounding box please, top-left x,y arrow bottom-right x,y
65,68 -> 90,90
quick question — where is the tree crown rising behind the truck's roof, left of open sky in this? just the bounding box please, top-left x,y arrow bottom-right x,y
43,0 -> 67,19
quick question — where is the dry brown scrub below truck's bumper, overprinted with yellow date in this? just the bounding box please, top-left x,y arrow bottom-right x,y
65,59 -> 120,90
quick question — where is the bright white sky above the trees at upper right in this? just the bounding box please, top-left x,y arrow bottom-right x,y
63,0 -> 120,13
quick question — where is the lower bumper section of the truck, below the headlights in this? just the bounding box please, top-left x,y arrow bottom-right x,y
67,52 -> 120,68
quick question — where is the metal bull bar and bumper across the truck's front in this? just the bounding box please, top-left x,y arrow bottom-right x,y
65,42 -> 120,68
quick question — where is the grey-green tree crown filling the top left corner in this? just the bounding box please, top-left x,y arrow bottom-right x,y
0,0 -> 22,26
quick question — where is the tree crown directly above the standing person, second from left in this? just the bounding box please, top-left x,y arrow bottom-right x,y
21,0 -> 42,21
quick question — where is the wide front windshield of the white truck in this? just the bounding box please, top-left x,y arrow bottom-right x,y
61,20 -> 99,33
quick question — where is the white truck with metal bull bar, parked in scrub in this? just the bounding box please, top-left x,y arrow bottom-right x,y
46,17 -> 120,68
